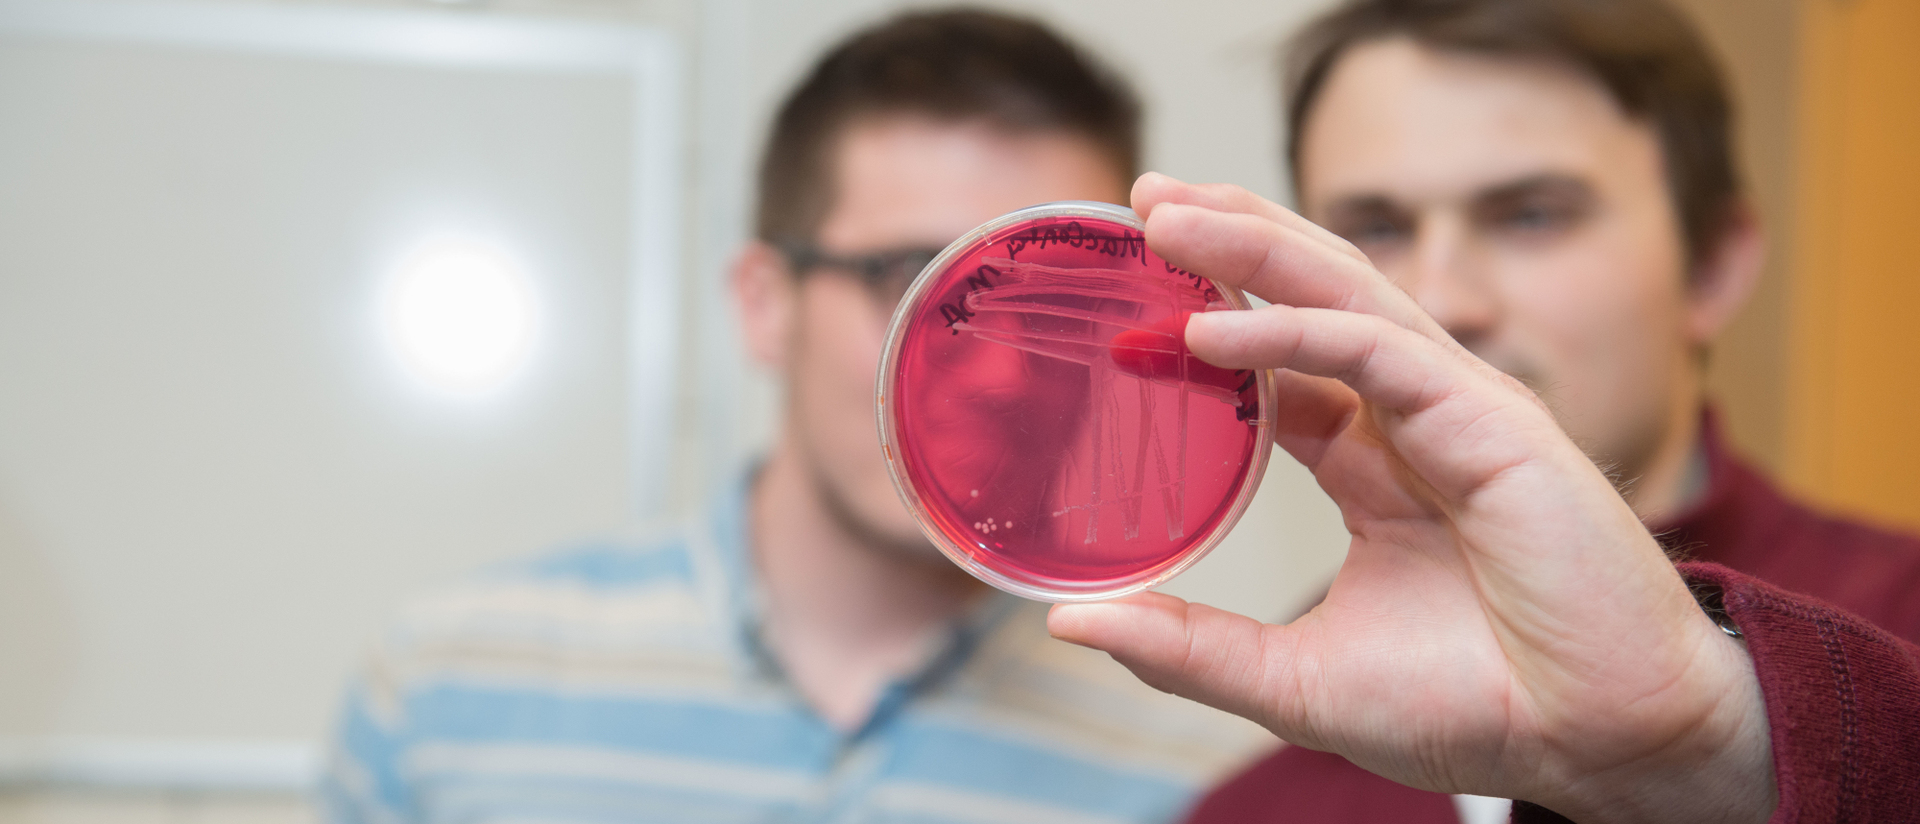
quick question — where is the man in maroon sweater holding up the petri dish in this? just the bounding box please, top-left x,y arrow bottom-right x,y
1062,0 -> 1920,822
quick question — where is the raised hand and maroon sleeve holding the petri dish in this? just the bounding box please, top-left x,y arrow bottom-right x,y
1048,175 -> 1920,824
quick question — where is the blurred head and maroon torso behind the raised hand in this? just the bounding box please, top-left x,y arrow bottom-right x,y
1196,0 -> 1920,822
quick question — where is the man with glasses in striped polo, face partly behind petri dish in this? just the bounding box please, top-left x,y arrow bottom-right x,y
326,12 -> 1271,822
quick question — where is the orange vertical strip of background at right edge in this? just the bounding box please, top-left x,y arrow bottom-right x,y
1786,0 -> 1920,528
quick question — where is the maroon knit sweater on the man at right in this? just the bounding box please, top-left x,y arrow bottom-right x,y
1188,415 -> 1920,824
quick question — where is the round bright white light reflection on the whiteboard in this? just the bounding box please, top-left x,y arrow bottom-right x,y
380,238 -> 540,396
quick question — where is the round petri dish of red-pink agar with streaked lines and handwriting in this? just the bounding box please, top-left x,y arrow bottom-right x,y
876,202 -> 1273,601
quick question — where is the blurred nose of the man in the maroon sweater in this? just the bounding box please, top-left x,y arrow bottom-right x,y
1400,215 -> 1500,350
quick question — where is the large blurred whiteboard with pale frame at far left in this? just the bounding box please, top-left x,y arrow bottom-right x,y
0,0 -> 684,789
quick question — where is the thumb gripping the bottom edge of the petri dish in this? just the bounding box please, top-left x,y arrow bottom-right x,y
1046,592 -> 1298,738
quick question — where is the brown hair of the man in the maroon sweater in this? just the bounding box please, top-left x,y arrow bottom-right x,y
1283,0 -> 1740,261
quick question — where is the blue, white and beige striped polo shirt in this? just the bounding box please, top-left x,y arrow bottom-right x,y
323,474 -> 1275,824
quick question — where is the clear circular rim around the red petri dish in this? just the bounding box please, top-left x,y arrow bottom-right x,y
874,200 -> 1275,603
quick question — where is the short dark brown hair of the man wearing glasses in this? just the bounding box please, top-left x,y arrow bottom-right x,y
755,10 -> 1140,242
